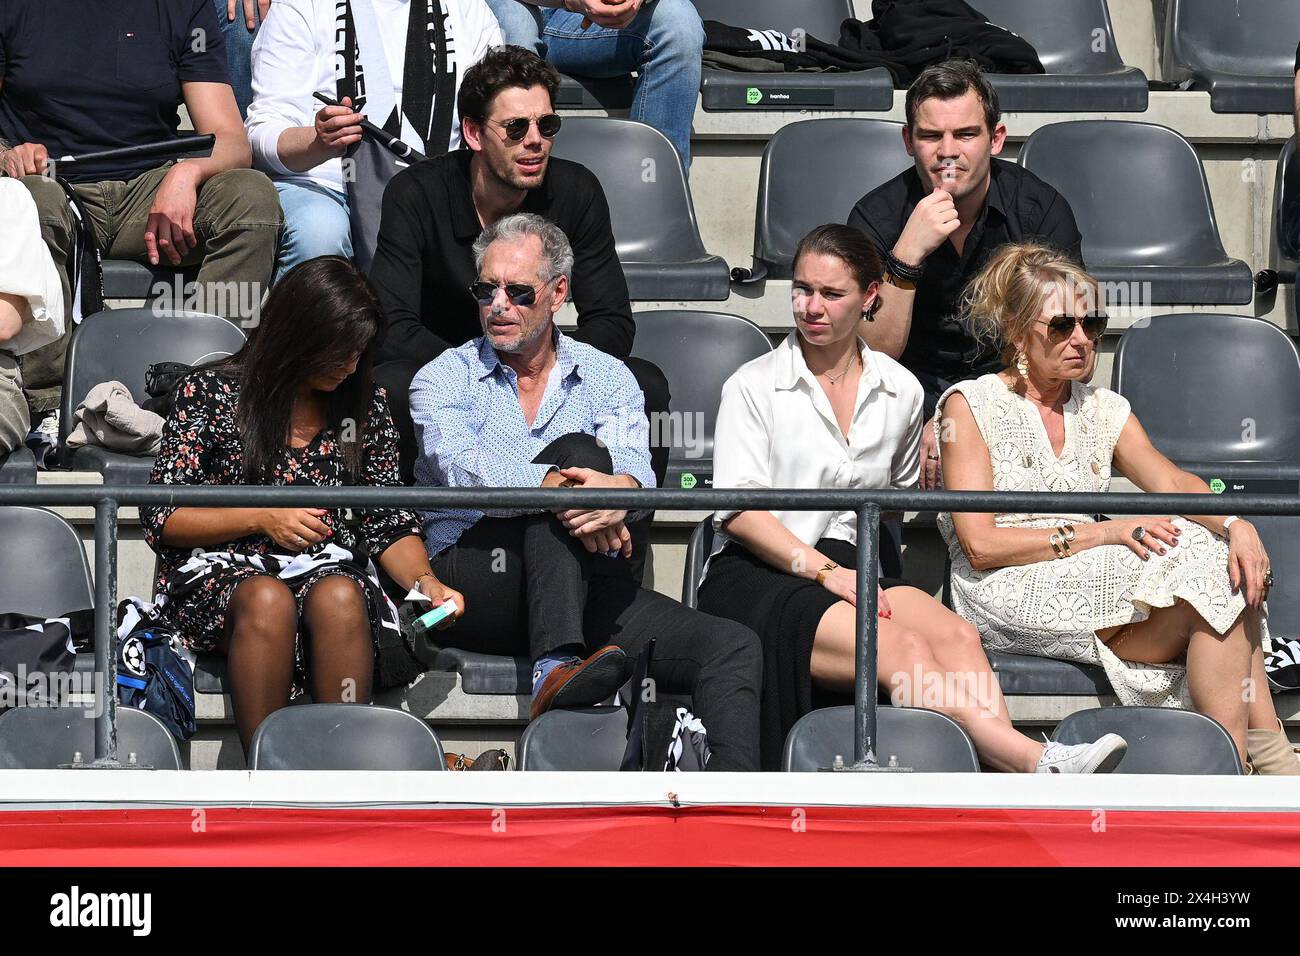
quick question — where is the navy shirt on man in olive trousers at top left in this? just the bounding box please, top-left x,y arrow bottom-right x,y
0,0 -> 230,182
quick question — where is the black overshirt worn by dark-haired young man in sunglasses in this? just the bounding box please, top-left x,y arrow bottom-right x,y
371,150 -> 636,363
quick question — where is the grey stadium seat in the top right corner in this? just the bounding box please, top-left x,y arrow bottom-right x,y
1164,0 -> 1300,113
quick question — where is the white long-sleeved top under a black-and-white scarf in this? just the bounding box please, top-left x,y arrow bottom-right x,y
244,0 -> 502,193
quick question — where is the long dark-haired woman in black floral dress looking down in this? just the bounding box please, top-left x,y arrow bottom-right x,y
140,256 -> 464,753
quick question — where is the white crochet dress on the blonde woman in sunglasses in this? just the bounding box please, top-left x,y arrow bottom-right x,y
939,375 -> 1268,706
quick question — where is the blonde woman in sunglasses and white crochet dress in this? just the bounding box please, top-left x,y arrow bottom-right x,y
936,245 -> 1300,774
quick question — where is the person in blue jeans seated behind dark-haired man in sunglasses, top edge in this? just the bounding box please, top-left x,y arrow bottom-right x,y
488,0 -> 705,169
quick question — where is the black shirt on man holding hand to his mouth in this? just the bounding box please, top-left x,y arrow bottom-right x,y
849,159 -> 1083,381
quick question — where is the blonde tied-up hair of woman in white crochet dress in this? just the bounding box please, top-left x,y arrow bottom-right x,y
962,242 -> 1099,367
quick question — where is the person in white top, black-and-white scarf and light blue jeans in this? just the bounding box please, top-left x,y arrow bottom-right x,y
244,0 -> 502,280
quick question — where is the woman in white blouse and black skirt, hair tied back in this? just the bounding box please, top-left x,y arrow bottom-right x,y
699,225 -> 1126,773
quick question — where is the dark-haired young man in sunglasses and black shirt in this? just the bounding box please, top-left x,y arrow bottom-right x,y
371,47 -> 668,576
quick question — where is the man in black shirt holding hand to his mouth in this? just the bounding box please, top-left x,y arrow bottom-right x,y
849,60 -> 1083,488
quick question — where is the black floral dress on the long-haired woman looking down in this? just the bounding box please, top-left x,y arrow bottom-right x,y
140,369 -> 420,683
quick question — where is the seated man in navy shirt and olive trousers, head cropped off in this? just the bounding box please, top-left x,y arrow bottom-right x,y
0,0 -> 281,418
